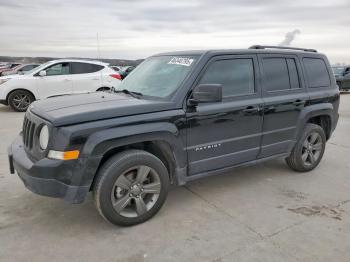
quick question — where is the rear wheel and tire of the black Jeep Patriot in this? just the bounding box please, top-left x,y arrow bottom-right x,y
286,123 -> 327,172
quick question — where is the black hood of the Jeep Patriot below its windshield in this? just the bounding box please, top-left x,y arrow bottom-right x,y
29,92 -> 178,126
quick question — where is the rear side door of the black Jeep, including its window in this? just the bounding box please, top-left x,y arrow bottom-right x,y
258,54 -> 309,158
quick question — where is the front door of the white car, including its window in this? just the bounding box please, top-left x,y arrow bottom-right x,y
35,62 -> 73,99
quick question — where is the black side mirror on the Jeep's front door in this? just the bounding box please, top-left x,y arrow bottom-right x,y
189,84 -> 222,104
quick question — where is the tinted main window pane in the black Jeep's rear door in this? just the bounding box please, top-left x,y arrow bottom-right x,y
263,58 -> 290,91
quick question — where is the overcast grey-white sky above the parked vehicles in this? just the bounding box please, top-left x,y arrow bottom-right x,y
0,0 -> 350,63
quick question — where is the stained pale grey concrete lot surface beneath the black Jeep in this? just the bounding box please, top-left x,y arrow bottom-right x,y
0,94 -> 350,262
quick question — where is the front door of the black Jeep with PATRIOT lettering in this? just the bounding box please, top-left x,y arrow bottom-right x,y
186,55 -> 263,175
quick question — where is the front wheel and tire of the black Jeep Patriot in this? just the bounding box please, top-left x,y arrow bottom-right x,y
93,150 -> 170,226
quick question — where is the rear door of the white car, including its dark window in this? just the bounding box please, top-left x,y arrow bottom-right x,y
71,62 -> 104,93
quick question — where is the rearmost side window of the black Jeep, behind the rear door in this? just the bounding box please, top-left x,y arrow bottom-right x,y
303,58 -> 331,87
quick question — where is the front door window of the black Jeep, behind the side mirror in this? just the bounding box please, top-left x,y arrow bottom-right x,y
200,58 -> 254,97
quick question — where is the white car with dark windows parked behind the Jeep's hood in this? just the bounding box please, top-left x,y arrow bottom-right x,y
0,59 -> 120,112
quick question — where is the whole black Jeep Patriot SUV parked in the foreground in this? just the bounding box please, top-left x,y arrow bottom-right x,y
9,46 -> 339,226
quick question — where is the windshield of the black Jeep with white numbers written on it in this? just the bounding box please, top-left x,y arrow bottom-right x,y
118,56 -> 198,98
